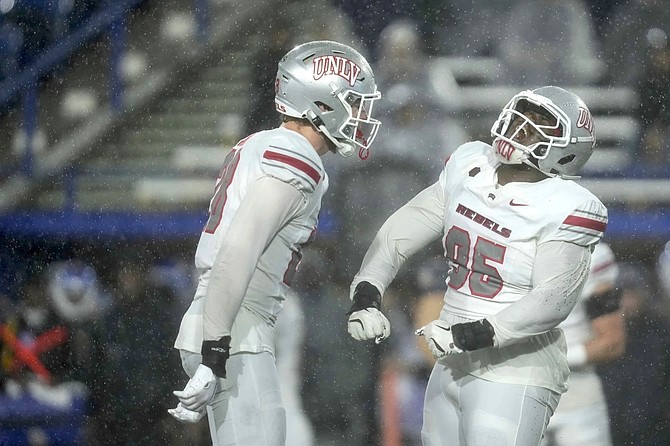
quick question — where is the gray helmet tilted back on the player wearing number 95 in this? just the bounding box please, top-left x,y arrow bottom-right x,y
491,86 -> 596,178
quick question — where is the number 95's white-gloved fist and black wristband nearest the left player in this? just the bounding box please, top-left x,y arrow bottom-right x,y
347,282 -> 391,344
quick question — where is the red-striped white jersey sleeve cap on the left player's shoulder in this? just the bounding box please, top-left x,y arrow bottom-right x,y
261,138 -> 325,194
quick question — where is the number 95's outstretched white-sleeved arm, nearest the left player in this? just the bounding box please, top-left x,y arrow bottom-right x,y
351,184 -> 444,296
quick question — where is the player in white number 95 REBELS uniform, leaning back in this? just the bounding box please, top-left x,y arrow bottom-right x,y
348,86 -> 607,446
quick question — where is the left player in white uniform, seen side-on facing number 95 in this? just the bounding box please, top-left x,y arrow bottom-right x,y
169,41 -> 380,446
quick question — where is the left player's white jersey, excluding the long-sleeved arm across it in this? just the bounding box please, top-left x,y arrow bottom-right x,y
175,127 -> 328,353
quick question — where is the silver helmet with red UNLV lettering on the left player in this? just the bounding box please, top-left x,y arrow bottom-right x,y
275,41 -> 381,158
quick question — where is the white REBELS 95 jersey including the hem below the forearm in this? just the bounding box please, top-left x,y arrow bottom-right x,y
439,141 -> 607,392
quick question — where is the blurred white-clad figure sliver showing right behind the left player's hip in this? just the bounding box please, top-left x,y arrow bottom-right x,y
275,290 -> 316,446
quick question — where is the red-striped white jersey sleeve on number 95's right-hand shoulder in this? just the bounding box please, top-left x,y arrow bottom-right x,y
550,198 -> 607,246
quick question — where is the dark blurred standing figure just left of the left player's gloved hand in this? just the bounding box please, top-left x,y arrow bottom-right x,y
93,253 -> 188,446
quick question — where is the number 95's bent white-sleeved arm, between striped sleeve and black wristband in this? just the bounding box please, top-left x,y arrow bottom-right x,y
487,242 -> 590,345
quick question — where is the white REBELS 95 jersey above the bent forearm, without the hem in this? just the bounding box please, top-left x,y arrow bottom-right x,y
439,141 -> 607,319
